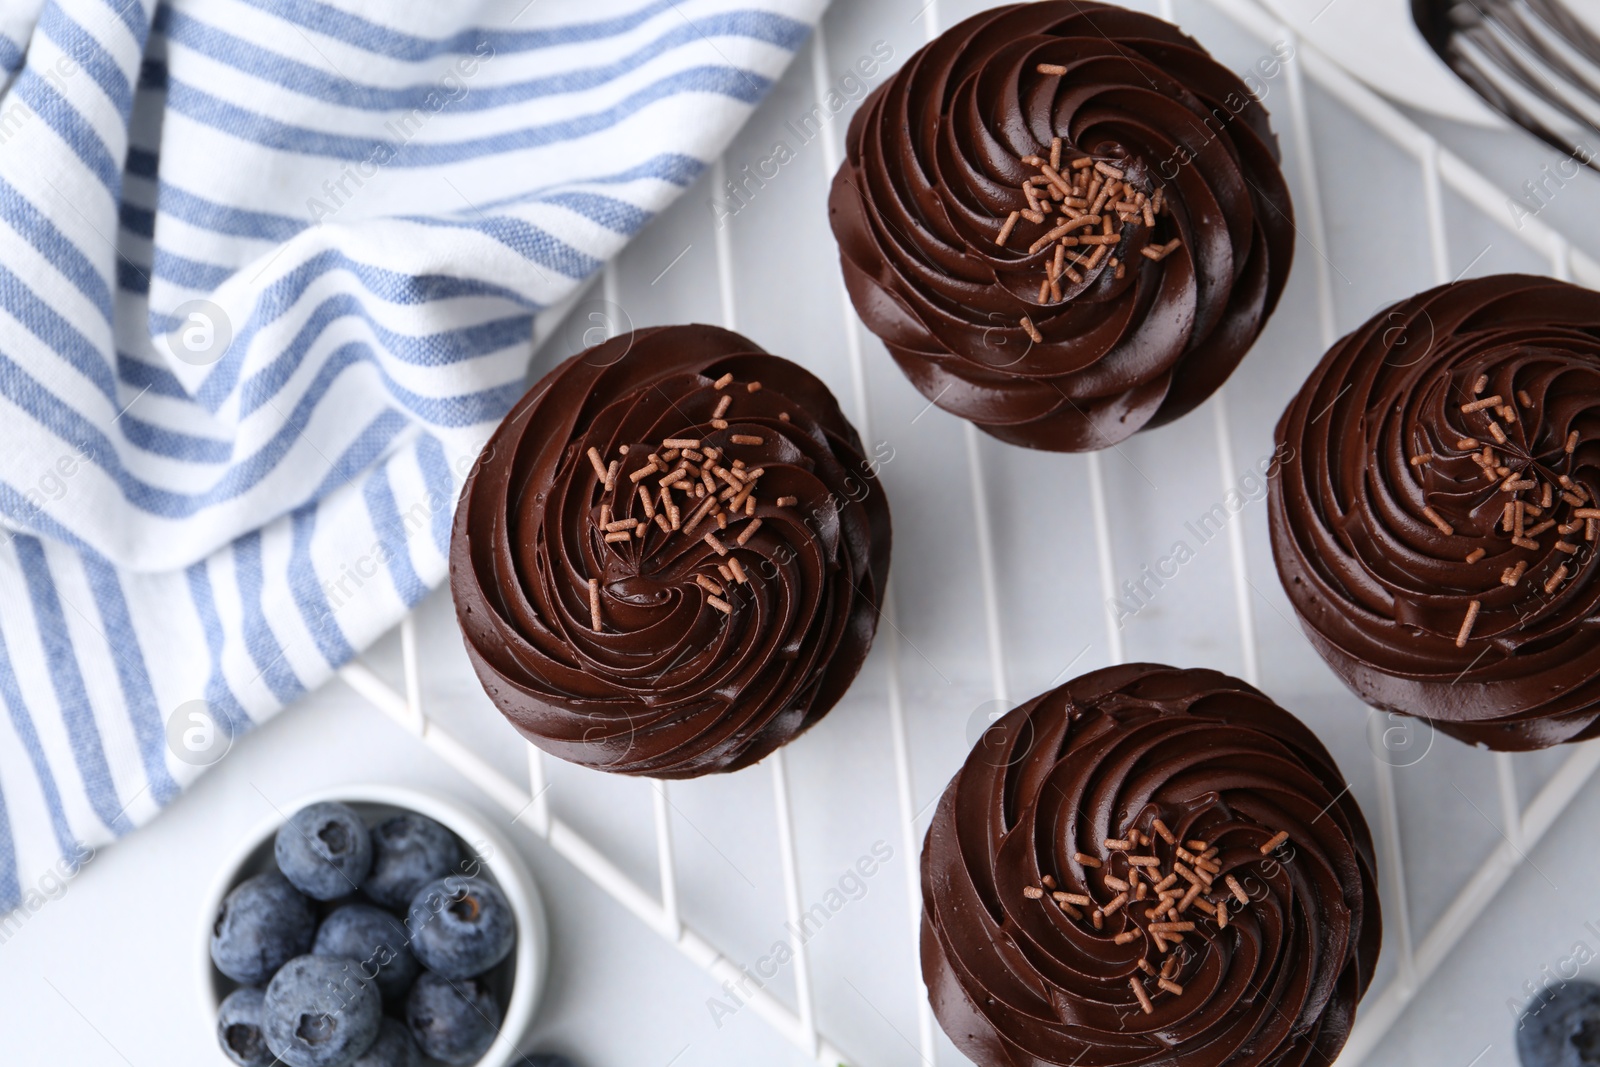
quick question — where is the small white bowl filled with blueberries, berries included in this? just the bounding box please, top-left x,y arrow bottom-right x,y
202,785 -> 550,1067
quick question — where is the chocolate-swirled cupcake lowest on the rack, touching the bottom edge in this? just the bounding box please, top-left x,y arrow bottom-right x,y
922,664 -> 1379,1067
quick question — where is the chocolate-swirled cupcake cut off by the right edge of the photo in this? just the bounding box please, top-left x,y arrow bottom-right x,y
1269,275 -> 1600,750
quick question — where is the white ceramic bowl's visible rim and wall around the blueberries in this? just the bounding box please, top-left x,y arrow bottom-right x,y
198,785 -> 550,1067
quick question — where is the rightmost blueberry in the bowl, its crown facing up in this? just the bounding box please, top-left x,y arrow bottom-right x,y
406,875 -> 517,977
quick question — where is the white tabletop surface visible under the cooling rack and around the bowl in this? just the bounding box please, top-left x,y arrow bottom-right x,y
9,0 -> 1600,1067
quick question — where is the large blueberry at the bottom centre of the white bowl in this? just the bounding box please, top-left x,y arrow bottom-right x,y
261,957 -> 384,1067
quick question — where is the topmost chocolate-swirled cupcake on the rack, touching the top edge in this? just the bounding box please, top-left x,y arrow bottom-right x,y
829,0 -> 1294,451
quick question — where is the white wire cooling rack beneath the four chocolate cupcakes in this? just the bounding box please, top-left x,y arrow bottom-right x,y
342,0 -> 1600,1067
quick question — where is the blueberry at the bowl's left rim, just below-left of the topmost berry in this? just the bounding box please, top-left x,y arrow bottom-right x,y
211,870 -> 317,985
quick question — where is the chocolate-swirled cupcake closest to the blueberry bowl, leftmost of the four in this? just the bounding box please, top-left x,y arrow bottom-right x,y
450,326 -> 890,777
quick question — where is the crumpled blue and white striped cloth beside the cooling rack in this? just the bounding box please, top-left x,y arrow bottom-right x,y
0,0 -> 824,913
